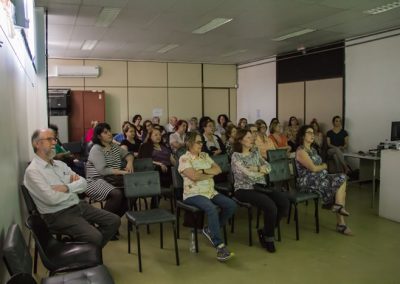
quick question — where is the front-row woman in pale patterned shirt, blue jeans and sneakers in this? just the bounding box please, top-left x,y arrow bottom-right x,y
178,132 -> 236,261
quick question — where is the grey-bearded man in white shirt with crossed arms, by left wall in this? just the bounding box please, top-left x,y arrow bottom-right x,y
24,129 -> 121,247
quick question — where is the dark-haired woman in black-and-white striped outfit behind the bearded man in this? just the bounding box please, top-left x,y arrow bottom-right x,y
86,123 -> 133,216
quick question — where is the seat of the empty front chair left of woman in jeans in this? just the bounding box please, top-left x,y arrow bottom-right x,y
126,208 -> 176,225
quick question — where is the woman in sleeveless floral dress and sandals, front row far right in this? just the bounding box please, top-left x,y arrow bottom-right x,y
296,125 -> 352,235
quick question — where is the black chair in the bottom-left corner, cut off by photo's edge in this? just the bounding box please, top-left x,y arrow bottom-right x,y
3,224 -> 114,284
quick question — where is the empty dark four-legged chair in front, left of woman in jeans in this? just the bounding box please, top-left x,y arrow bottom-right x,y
124,171 -> 179,272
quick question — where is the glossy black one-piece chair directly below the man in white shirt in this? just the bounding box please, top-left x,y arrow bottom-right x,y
26,214 -> 103,275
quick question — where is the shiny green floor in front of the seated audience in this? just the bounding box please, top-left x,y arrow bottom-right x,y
35,185 -> 400,284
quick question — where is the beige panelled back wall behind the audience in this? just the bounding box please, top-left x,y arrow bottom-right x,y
49,59 -> 237,131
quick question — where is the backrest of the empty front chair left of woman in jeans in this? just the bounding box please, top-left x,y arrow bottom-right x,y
124,171 -> 161,198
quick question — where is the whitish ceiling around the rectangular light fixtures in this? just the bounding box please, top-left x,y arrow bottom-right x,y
36,0 -> 400,64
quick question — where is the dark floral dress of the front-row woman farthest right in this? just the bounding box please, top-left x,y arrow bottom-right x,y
296,146 -> 346,205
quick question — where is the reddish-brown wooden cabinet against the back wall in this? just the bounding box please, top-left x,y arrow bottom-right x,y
68,91 -> 106,141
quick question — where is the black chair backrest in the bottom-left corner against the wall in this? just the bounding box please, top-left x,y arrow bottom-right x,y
3,224 -> 32,276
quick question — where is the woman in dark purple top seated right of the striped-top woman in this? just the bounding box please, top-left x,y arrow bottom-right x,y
138,128 -> 175,187
